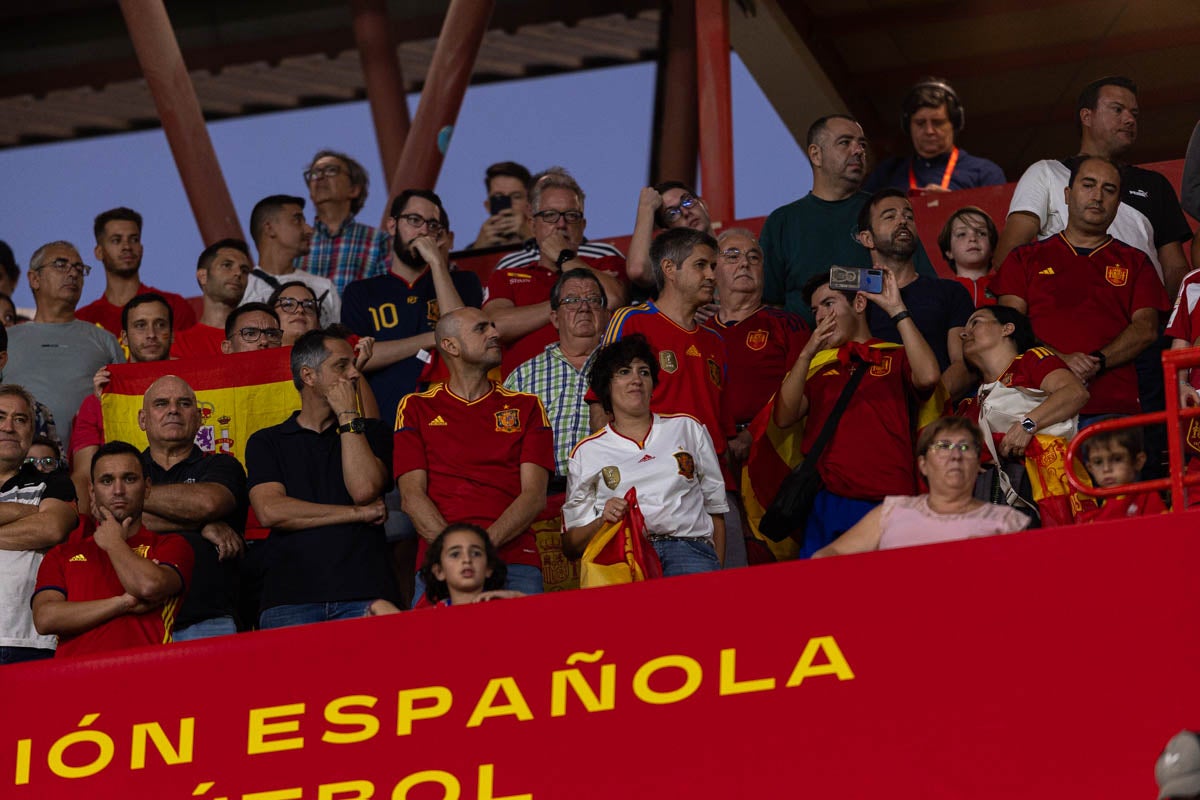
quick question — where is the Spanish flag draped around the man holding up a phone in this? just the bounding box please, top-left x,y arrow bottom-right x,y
742,342 -> 948,561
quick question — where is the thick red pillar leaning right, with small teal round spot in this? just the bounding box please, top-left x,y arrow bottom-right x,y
389,0 -> 496,201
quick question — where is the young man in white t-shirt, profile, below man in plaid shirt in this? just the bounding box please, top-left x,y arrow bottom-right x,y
241,194 -> 342,326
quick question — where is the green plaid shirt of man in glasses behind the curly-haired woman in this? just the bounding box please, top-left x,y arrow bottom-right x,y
504,342 -> 599,475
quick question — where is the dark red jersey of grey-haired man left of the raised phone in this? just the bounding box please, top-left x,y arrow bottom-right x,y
704,306 -> 810,425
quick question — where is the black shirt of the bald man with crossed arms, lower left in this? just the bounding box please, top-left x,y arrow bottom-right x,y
142,445 -> 248,628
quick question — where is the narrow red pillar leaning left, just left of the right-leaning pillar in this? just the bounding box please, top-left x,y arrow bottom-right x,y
350,0 -> 409,181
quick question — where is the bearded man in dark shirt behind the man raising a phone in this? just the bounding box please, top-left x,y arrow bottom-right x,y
858,188 -> 974,395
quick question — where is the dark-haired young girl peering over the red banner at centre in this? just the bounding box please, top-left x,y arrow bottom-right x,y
416,523 -> 523,608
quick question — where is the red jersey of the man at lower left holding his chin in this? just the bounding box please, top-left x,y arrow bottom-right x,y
34,519 -> 196,657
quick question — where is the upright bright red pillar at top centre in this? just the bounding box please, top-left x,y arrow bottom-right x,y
696,0 -> 737,223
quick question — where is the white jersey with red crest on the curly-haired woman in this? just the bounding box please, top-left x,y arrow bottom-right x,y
563,414 -> 730,539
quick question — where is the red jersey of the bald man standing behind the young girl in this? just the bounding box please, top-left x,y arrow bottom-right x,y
392,384 -> 554,567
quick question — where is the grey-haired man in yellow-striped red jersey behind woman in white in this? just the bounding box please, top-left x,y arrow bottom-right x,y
604,228 -> 744,564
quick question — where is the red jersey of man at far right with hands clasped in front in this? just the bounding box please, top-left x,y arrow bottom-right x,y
990,234 -> 1170,414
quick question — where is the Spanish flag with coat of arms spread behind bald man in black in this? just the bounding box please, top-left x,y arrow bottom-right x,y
100,348 -> 300,464
